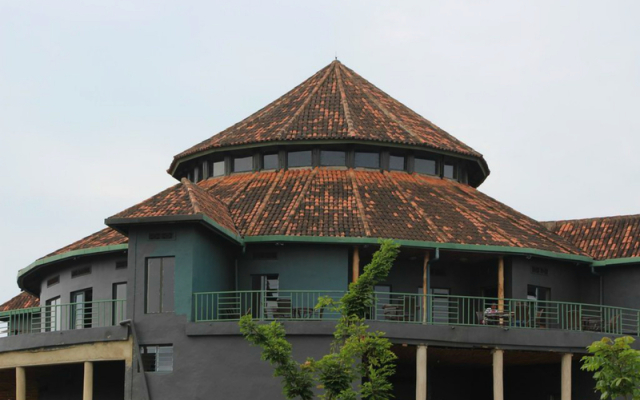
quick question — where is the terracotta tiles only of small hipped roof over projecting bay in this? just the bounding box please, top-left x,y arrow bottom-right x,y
110,178 -> 238,234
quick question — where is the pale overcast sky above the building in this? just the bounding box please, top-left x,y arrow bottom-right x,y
0,0 -> 640,303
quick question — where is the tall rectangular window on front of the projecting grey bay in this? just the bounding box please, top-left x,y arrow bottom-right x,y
145,257 -> 175,314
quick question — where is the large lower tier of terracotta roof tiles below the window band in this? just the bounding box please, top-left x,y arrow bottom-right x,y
190,168 -> 584,254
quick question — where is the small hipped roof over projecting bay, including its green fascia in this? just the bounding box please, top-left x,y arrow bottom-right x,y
105,178 -> 241,242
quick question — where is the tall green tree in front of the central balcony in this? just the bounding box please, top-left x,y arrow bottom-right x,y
240,240 -> 399,400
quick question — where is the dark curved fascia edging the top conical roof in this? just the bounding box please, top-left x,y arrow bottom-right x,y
167,139 -> 491,183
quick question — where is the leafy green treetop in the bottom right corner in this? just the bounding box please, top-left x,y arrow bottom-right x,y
581,336 -> 640,400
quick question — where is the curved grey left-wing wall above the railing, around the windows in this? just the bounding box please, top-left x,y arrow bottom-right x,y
40,253 -> 127,305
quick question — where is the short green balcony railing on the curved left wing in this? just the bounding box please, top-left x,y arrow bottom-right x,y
0,300 -> 126,337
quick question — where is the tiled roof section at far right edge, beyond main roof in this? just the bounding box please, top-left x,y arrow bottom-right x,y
544,215 -> 640,260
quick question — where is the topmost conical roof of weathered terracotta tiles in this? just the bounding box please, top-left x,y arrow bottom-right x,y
170,61 -> 482,170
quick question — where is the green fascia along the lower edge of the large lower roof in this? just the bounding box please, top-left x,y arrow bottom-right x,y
244,235 -> 593,264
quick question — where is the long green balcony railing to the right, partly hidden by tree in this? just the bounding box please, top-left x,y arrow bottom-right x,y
193,290 -> 640,335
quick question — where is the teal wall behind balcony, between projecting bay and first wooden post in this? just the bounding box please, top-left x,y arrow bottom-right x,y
238,244 -> 350,290
